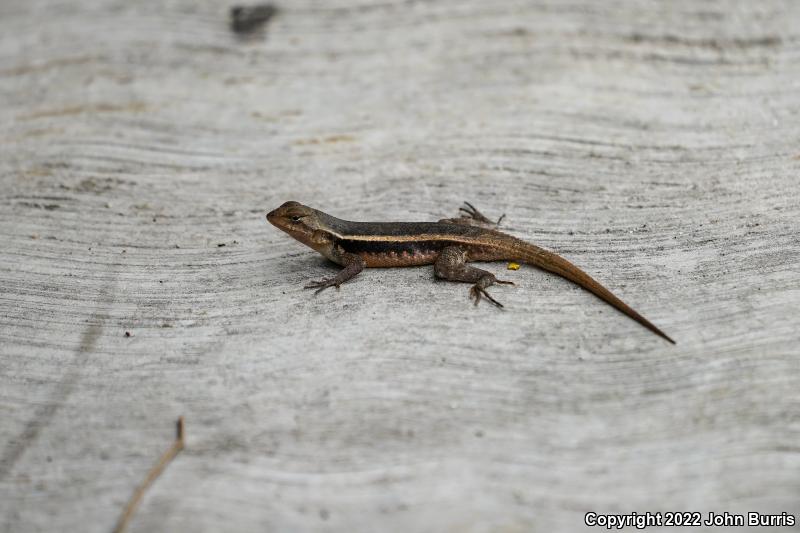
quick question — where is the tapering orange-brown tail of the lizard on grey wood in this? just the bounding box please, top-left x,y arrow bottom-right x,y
514,242 -> 675,344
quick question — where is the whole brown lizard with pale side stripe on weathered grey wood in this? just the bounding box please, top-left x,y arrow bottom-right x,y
267,201 -> 675,344
